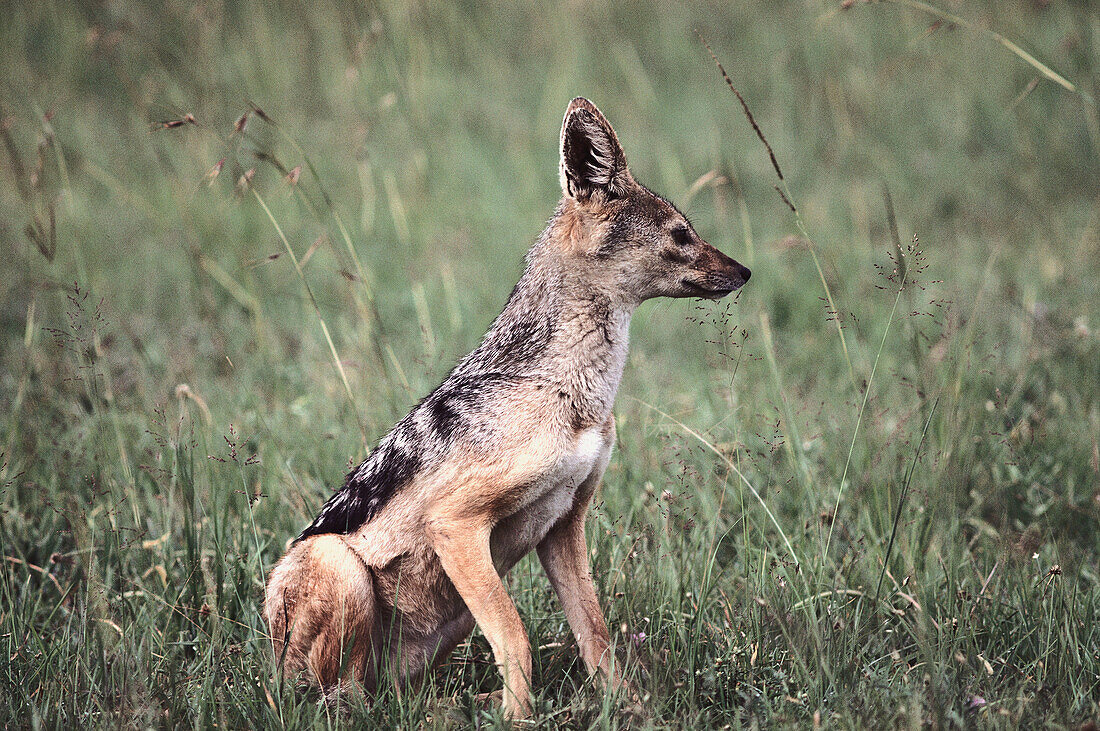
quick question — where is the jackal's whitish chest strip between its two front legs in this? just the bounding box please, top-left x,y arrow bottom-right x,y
493,425 -> 612,573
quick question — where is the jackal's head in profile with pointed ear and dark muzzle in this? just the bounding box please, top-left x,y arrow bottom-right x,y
558,98 -> 749,302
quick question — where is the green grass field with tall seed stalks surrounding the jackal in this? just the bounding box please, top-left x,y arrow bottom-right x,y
0,0 -> 1100,729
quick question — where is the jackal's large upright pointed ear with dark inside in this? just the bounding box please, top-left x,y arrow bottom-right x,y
560,97 -> 630,200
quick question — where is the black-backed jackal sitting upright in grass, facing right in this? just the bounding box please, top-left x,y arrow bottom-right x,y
264,93 -> 749,717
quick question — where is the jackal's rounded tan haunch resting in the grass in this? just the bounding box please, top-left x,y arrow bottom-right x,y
264,534 -> 376,696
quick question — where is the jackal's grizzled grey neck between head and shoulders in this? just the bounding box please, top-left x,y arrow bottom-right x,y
457,211 -> 636,423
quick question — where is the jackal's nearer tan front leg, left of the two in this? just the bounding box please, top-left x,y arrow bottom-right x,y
427,519 -> 531,718
